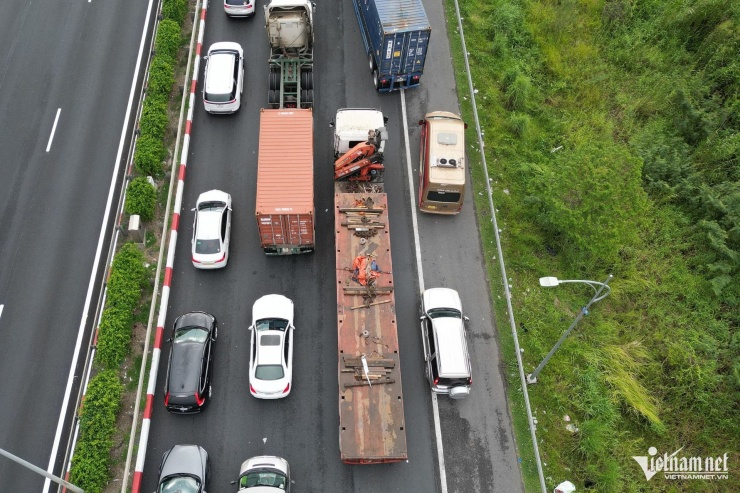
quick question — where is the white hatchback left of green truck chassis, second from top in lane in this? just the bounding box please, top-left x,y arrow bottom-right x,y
203,41 -> 244,113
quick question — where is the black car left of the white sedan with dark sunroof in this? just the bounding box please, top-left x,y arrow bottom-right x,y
164,312 -> 218,414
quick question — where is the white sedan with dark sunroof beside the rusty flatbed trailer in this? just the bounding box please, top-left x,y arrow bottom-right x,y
249,294 -> 295,399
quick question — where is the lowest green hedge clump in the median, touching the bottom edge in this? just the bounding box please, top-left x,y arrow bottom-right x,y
69,370 -> 123,493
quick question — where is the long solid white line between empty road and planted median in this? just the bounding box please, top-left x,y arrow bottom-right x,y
42,0 -> 153,493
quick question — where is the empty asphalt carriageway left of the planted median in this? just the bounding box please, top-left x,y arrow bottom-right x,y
0,0 -> 156,492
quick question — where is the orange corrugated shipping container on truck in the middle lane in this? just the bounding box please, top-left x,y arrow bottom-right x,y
255,108 -> 314,255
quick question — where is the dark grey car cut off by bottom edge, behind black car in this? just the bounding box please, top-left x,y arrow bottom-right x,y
157,445 -> 211,493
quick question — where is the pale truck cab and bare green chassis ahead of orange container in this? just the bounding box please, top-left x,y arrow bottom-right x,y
265,0 -> 315,108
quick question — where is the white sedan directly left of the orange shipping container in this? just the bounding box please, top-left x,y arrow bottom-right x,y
192,190 -> 231,269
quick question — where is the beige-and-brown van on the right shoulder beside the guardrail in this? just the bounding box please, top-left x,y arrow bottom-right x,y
419,111 -> 467,214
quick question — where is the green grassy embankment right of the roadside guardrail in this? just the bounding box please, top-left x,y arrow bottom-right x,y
446,0 -> 740,492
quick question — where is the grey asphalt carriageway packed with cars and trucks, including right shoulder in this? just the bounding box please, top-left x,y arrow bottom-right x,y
143,2 -> 522,493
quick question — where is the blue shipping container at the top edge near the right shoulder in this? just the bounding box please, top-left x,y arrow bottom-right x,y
352,0 -> 432,92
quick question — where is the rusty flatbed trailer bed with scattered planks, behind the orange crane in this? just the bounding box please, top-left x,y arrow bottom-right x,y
334,182 -> 408,464
